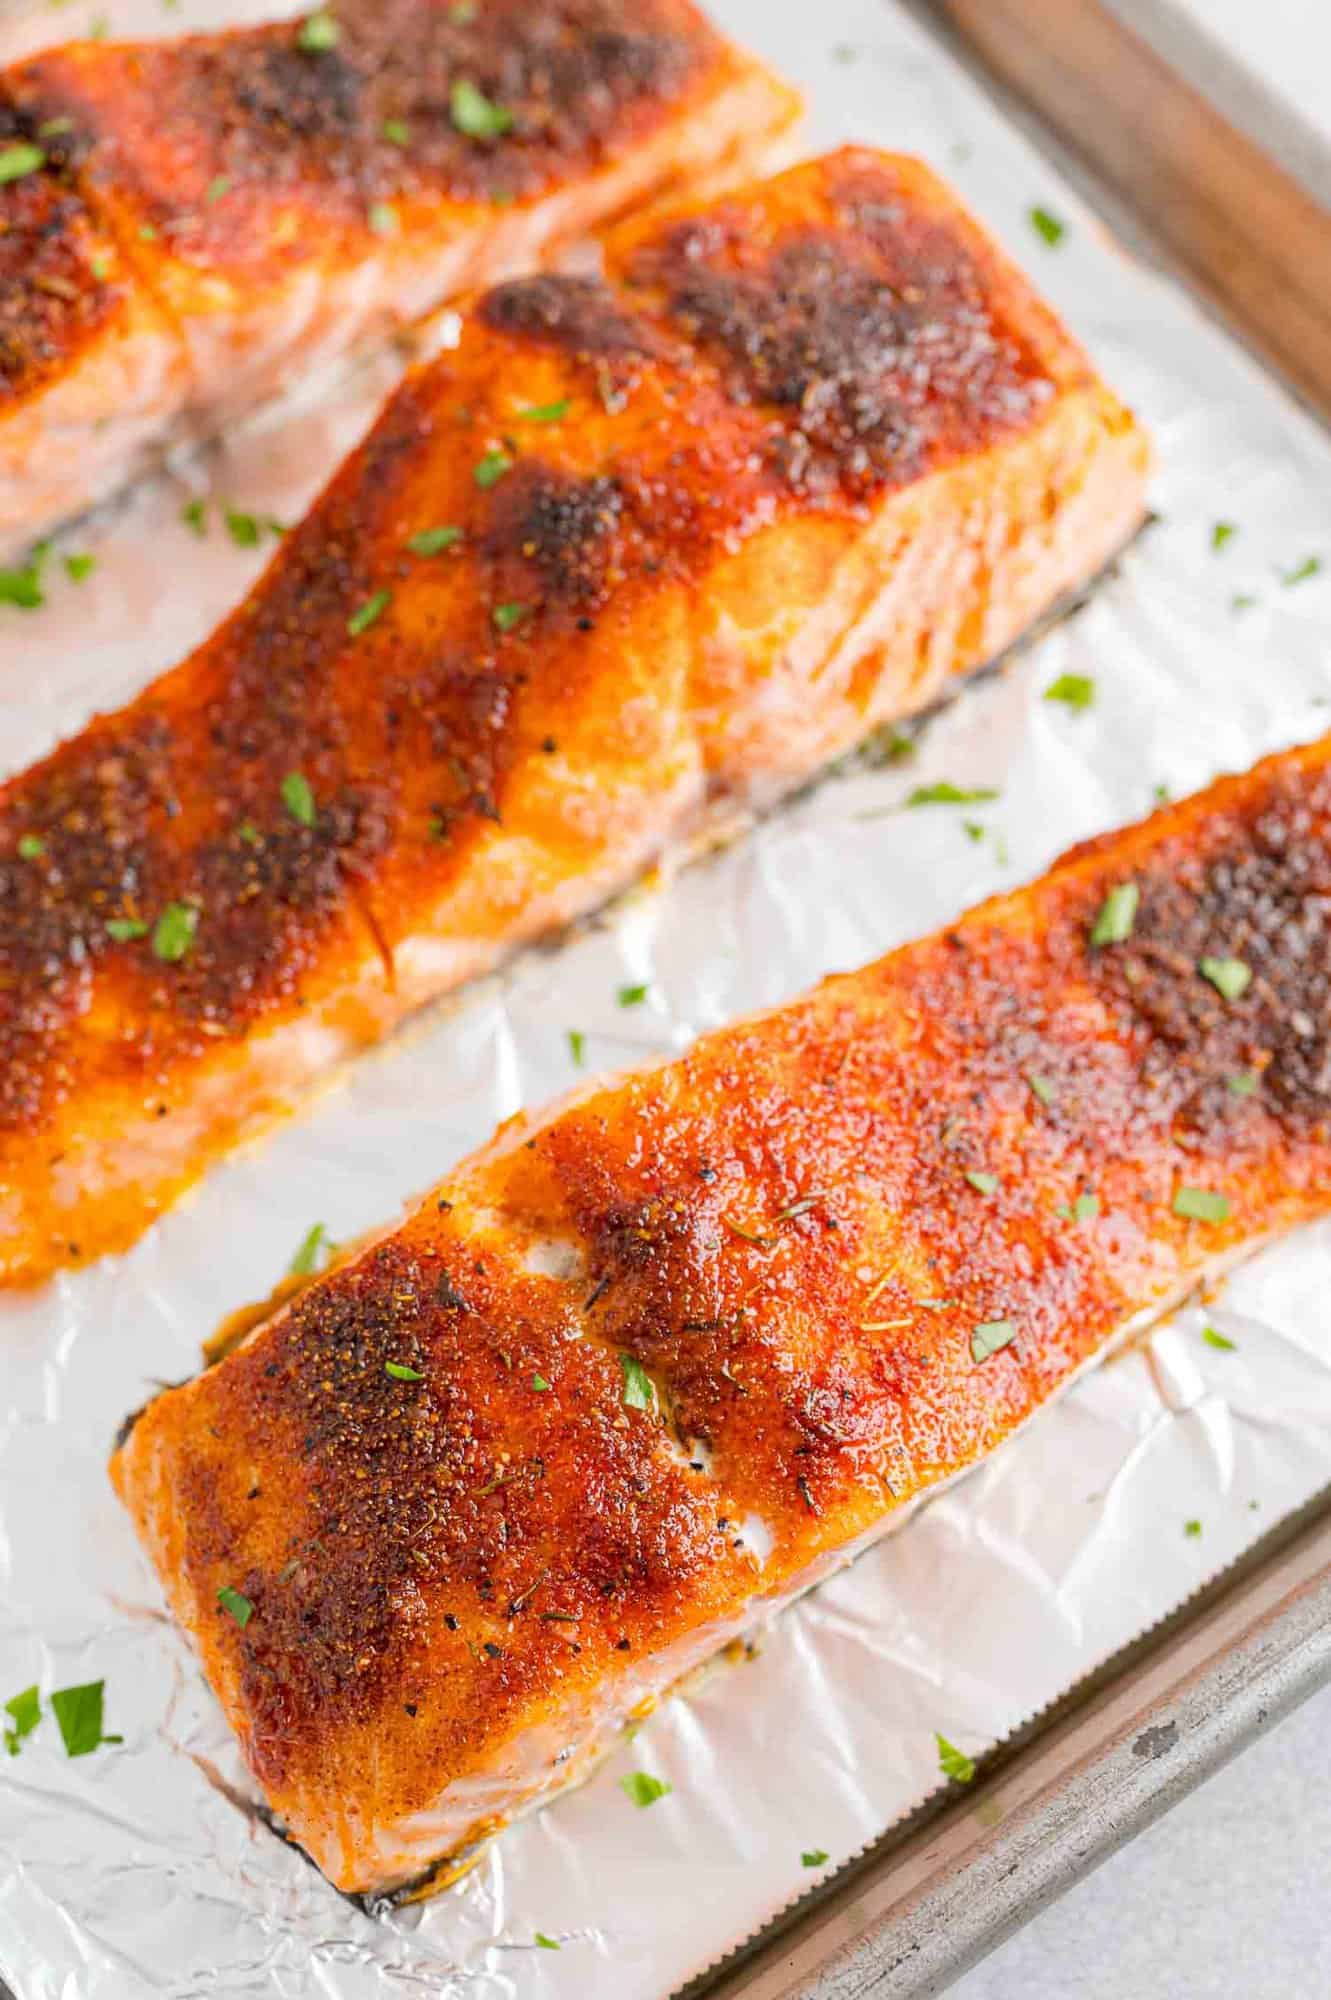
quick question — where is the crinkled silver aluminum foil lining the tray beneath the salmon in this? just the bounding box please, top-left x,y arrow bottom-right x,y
0,0 -> 1331,2000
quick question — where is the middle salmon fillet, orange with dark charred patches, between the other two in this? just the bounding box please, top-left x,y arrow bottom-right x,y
0,152 -> 1147,1282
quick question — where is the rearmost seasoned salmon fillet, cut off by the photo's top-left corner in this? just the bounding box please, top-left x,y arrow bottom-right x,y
0,0 -> 799,550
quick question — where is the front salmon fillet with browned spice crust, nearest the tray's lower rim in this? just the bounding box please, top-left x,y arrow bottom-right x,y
112,738 -> 1331,1890
